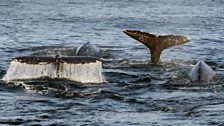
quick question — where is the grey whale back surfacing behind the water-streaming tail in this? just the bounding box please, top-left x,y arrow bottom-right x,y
76,42 -> 100,57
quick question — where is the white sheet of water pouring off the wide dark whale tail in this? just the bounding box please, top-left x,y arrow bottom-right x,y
3,60 -> 105,83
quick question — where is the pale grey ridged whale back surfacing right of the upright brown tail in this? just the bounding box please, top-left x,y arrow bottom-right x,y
188,61 -> 216,82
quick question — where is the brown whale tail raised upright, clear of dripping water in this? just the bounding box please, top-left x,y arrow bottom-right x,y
123,30 -> 189,65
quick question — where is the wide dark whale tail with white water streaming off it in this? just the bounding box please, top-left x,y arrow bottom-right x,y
3,55 -> 104,83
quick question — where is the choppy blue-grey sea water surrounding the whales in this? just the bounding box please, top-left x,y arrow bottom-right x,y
0,0 -> 224,126
